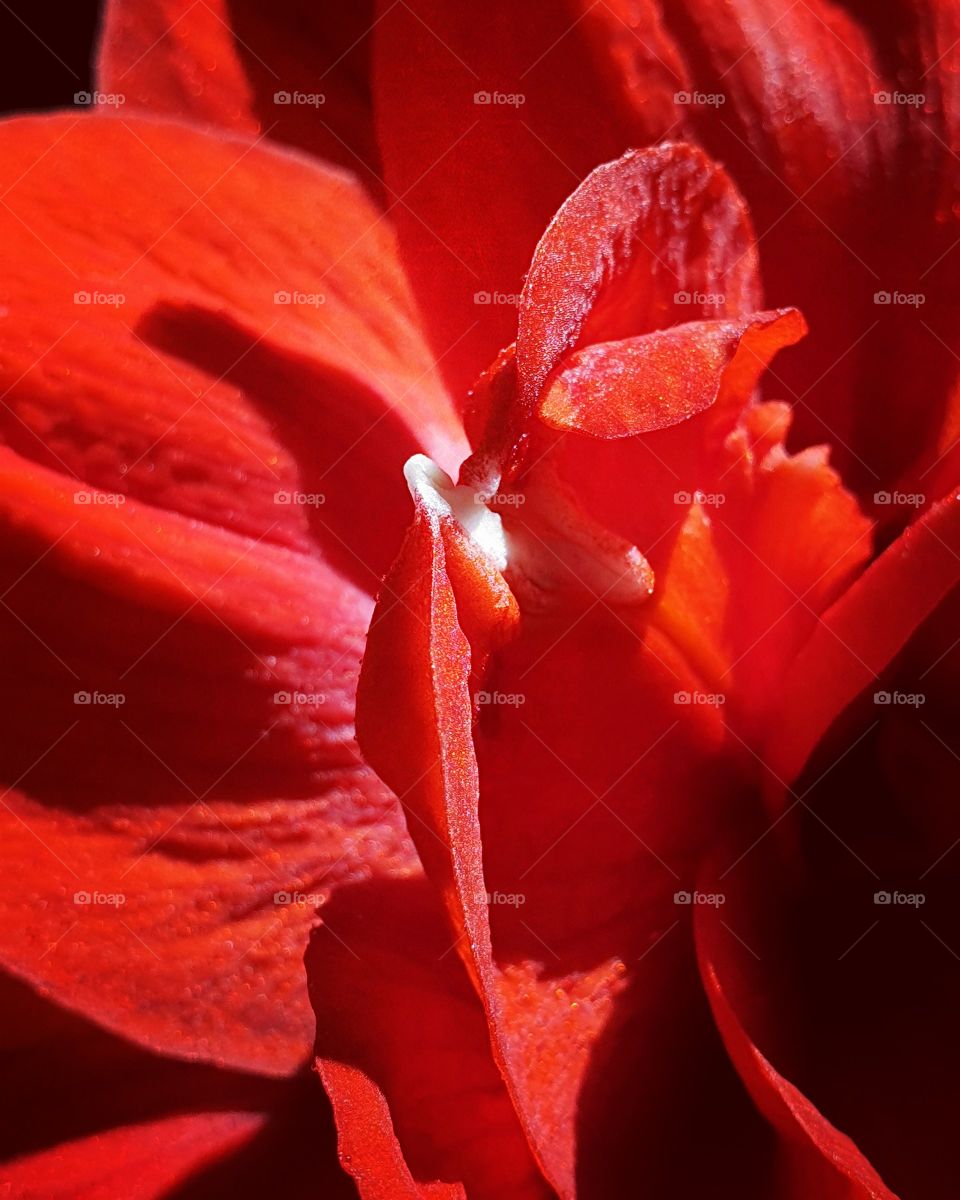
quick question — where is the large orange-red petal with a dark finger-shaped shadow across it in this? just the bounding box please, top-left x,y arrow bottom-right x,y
0,116 -> 460,590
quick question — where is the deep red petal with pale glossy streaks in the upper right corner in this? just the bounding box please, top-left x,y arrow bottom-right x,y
668,0 -> 960,501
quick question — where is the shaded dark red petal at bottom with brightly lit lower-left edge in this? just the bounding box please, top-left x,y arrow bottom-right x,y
307,877 -> 547,1200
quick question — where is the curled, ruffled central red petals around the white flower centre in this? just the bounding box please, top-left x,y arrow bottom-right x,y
359,146 -> 892,1196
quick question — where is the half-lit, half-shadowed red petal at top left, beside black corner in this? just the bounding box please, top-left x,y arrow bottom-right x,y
97,0 -> 378,184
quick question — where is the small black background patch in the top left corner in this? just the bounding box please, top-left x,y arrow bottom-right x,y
0,0 -> 101,114
